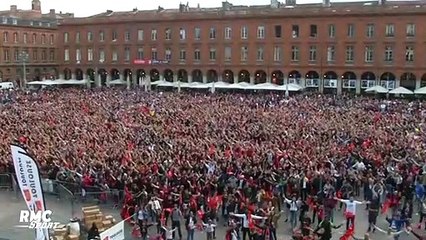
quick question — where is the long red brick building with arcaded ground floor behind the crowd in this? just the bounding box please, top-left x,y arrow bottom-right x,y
58,1 -> 426,93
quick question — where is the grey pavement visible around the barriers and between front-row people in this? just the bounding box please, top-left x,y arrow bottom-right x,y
0,190 -> 419,240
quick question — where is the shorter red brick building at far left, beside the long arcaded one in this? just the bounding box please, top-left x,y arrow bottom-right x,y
0,0 -> 72,84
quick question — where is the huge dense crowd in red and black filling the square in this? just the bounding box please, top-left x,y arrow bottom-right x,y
0,89 -> 426,240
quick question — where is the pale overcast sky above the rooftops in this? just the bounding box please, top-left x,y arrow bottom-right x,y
0,0 -> 370,17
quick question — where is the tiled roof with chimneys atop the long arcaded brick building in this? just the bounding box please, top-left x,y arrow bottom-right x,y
60,0 -> 426,25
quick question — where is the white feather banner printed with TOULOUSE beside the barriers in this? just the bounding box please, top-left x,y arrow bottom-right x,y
11,145 -> 50,240
